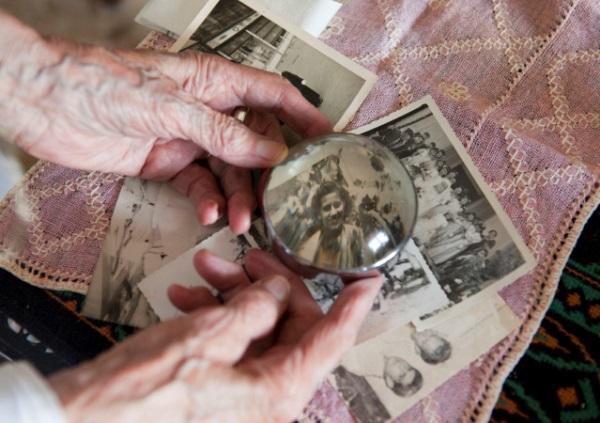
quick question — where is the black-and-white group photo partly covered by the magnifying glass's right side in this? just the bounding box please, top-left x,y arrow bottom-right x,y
355,98 -> 534,322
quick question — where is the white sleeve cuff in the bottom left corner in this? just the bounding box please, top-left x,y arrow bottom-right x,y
0,362 -> 66,423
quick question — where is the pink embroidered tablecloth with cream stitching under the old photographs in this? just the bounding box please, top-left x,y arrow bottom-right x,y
0,0 -> 600,422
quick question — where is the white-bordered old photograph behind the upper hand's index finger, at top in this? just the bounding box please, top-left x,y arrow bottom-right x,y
173,0 -> 376,130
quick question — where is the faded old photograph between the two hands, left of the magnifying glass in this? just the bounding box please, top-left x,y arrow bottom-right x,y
82,178 -> 216,327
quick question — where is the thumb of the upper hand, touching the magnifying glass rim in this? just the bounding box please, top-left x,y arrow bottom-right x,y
158,94 -> 287,167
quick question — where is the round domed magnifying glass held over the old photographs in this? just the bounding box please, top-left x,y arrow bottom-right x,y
261,133 -> 417,278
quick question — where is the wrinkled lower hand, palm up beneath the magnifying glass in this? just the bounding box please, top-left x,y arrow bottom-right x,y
50,250 -> 382,423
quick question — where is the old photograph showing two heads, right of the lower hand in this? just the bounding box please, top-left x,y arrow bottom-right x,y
328,294 -> 519,423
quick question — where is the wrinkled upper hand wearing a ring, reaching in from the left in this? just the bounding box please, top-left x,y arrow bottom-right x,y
0,11 -> 331,233
